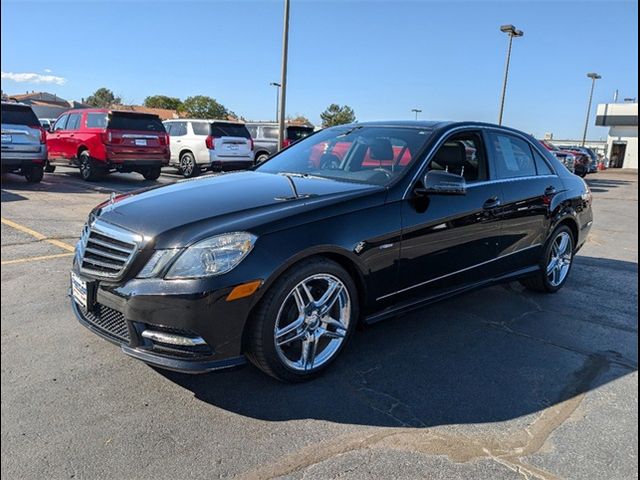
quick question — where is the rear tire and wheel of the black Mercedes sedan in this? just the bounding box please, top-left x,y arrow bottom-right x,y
520,225 -> 575,293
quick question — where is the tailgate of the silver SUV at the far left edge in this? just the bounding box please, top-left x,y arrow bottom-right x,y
2,103 -> 44,153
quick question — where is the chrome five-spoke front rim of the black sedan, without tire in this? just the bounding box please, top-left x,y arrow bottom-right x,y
274,274 -> 351,372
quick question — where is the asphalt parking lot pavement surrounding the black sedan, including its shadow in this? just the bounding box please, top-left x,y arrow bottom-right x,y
1,168 -> 638,479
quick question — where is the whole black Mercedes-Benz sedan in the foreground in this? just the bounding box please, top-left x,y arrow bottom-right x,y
70,122 -> 592,381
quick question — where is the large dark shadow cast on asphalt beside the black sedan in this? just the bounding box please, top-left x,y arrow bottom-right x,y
158,257 -> 638,428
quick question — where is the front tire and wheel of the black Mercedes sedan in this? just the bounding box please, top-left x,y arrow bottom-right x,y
247,258 -> 359,382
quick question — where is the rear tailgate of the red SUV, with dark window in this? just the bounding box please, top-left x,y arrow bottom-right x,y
107,112 -> 166,157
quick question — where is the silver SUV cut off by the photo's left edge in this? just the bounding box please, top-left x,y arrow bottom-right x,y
1,102 -> 47,183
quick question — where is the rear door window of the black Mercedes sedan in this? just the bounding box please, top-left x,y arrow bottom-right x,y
489,133 -> 536,178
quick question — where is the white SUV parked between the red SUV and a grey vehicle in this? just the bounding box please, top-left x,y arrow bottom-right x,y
164,118 -> 253,178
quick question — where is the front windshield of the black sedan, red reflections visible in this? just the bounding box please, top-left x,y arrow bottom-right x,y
256,126 -> 432,186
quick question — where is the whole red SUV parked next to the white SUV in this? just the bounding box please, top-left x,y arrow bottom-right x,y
47,109 -> 171,181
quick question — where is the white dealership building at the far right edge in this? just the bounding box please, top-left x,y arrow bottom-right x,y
596,101 -> 638,169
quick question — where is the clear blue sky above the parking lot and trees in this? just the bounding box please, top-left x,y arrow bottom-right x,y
1,0 -> 638,139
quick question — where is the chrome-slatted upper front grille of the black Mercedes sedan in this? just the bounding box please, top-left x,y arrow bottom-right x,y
78,220 -> 141,280
